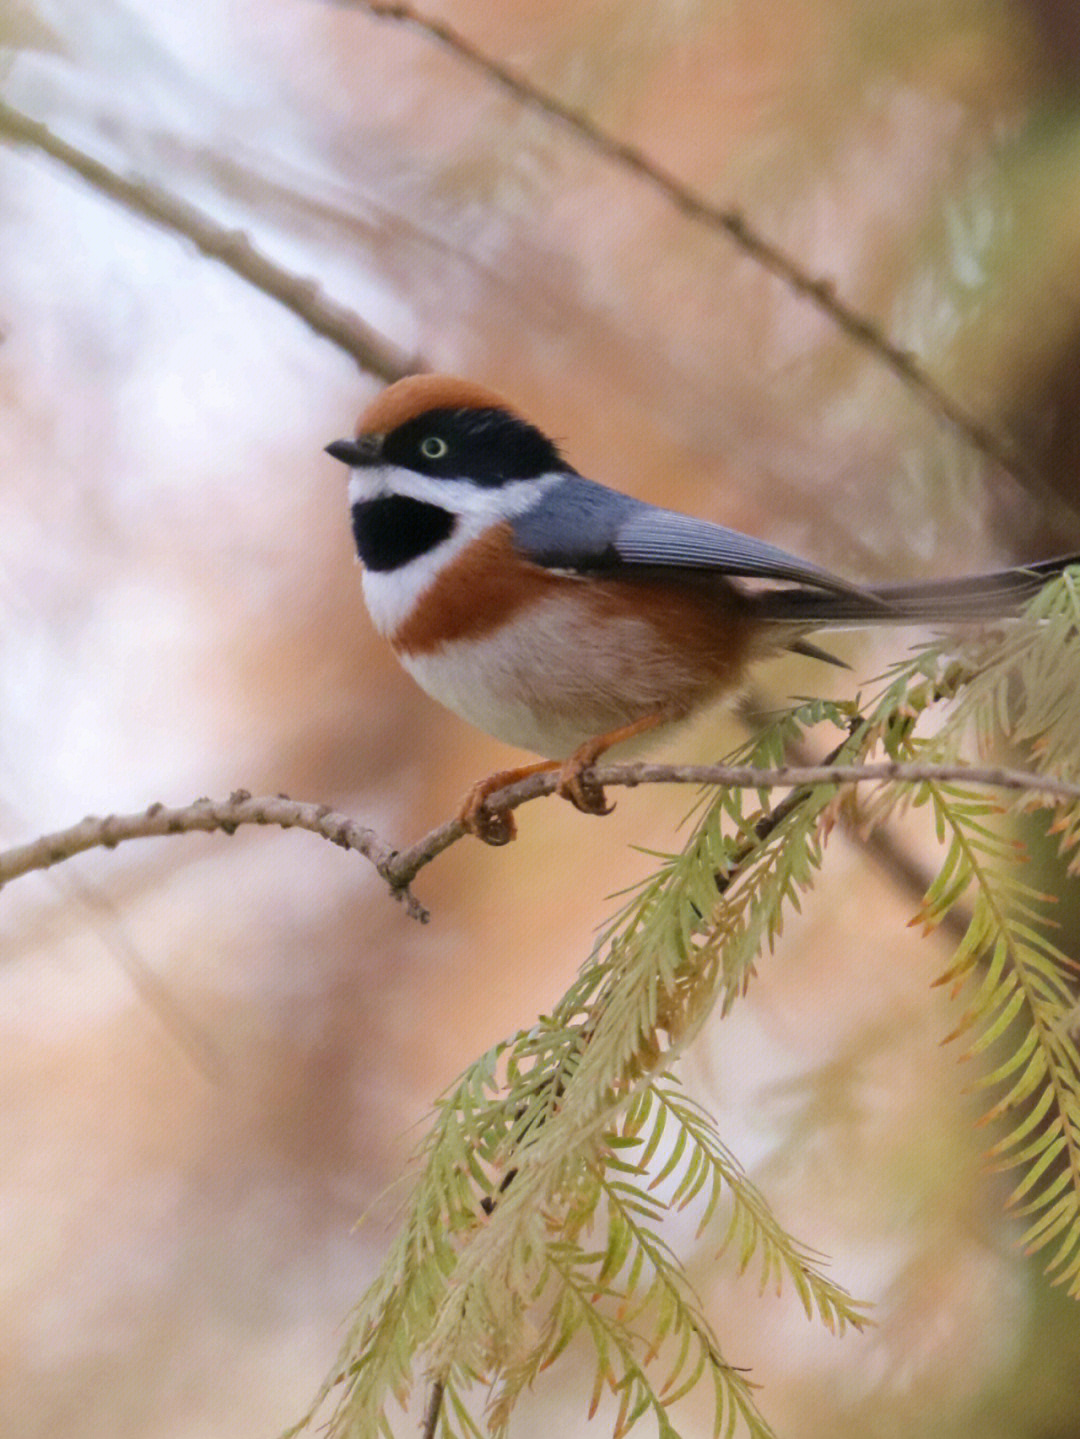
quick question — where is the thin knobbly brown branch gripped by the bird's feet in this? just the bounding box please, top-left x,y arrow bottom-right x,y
0,761 -> 1080,920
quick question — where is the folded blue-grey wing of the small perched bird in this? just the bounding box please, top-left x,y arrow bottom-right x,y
513,475 -> 863,594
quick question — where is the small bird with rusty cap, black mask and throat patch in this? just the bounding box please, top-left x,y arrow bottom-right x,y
326,374 -> 1080,843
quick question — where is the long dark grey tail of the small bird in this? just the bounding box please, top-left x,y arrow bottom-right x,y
758,554 -> 1080,630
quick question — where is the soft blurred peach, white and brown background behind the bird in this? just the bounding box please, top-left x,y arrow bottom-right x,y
0,0 -> 1080,1439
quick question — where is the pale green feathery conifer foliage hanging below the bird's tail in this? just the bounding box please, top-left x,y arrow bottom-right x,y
293,571 -> 1080,1439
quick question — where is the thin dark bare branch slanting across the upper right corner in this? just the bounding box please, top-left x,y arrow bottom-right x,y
343,0 -> 1077,528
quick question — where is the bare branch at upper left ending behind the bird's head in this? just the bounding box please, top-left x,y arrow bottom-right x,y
0,99 -> 423,381
